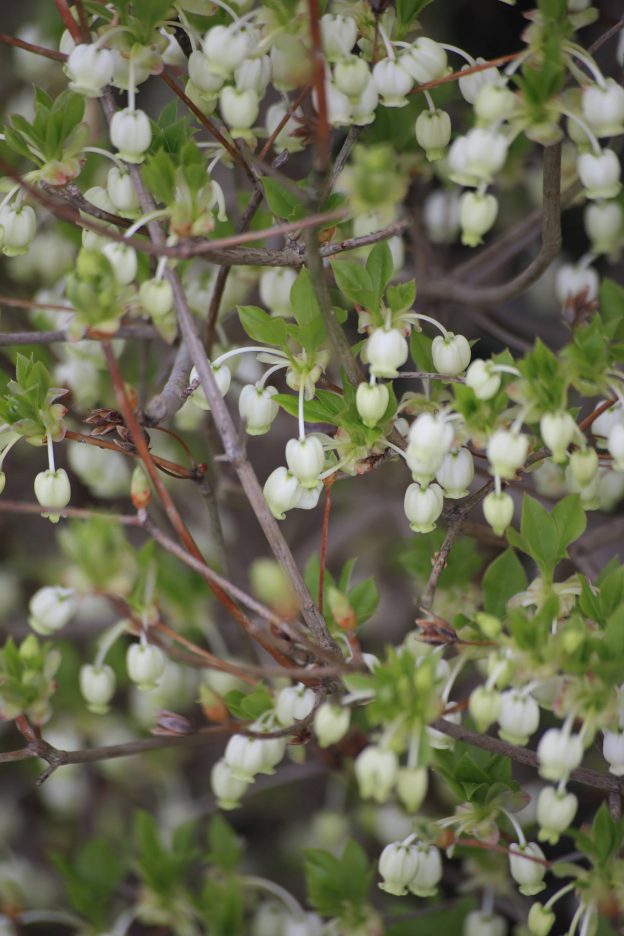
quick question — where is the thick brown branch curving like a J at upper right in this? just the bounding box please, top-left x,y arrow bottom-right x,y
420,143 -> 561,306
